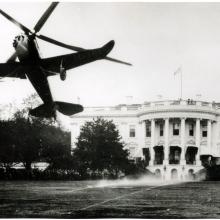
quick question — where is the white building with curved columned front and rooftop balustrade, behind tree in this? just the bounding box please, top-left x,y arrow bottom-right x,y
71,100 -> 220,180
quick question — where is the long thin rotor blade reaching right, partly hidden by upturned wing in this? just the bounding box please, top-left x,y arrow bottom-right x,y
36,35 -> 132,66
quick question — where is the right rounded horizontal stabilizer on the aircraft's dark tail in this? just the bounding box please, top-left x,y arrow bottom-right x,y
55,102 -> 83,116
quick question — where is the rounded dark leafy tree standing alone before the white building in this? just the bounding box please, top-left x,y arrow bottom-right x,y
73,118 -> 129,176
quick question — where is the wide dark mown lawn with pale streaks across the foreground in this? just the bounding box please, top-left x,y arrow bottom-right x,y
0,181 -> 220,218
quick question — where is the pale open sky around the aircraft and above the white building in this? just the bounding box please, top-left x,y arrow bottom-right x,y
0,2 -> 220,106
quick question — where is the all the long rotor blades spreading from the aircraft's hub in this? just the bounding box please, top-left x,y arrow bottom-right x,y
0,2 -> 132,66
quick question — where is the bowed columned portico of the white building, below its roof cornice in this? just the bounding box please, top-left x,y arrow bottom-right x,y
142,117 -> 214,180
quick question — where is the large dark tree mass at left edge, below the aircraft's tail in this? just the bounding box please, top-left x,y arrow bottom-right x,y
0,95 -> 72,177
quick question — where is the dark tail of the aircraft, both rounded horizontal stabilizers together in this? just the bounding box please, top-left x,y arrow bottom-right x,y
29,102 -> 83,118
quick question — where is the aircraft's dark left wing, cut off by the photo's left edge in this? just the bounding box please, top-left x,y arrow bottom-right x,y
0,62 -> 26,79
